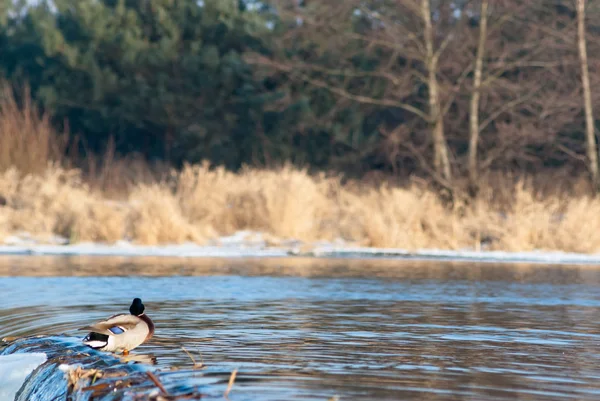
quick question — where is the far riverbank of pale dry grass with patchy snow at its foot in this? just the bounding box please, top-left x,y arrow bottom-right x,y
0,164 -> 600,254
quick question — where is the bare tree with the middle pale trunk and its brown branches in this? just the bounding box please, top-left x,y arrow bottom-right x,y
458,0 -> 577,178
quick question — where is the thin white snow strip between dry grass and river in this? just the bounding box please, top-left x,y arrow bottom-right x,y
0,231 -> 600,265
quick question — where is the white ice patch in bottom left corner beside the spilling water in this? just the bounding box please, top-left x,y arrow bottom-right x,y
0,352 -> 46,401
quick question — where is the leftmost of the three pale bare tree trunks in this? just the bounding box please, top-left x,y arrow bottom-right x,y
421,0 -> 452,183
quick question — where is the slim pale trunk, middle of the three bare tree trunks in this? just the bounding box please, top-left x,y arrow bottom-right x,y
468,0 -> 488,194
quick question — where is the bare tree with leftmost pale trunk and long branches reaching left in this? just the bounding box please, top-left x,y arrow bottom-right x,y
250,0 -> 471,188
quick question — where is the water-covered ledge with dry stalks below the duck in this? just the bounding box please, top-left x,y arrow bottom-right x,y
0,336 -> 228,401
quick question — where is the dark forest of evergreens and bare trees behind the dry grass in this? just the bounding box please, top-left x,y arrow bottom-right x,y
0,0 -> 600,194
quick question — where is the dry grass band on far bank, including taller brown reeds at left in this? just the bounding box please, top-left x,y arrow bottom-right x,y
0,84 -> 600,252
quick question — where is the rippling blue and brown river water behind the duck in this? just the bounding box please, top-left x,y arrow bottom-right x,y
0,257 -> 600,401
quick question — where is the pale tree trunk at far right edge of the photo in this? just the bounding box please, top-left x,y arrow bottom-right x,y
577,0 -> 600,192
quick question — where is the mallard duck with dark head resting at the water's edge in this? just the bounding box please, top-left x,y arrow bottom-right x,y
82,298 -> 154,355
